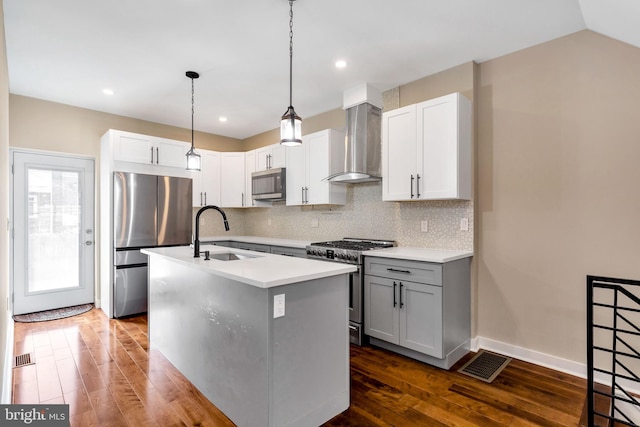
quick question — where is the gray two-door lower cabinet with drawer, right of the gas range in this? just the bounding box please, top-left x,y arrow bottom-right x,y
364,257 -> 471,369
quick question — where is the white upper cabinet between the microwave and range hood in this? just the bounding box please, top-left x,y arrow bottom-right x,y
286,129 -> 346,206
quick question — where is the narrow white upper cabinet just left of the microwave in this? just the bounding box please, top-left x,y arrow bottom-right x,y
220,152 -> 251,208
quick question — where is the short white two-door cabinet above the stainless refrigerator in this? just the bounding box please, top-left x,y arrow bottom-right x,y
112,131 -> 190,169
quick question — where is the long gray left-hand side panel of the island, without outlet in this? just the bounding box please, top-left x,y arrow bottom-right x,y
148,255 -> 269,426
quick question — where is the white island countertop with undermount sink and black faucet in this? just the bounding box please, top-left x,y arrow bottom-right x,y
142,246 -> 357,288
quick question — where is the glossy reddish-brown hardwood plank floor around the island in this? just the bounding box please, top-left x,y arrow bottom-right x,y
13,309 -> 586,427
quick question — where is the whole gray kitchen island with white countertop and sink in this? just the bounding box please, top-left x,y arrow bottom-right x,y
143,245 -> 355,426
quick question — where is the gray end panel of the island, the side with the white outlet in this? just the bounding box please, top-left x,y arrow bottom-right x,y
269,274 -> 350,427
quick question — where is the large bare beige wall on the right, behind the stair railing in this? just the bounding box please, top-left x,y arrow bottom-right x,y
476,31 -> 640,363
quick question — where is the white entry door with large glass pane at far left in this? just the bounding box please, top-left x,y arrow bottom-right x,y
13,151 -> 94,314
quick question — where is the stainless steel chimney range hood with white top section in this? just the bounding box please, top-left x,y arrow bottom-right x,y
325,83 -> 383,183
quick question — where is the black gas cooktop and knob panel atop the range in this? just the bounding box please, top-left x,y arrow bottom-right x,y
307,237 -> 396,265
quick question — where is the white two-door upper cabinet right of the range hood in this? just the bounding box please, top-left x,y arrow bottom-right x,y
382,93 -> 472,201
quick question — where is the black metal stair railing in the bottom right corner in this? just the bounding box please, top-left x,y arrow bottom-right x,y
587,276 -> 640,427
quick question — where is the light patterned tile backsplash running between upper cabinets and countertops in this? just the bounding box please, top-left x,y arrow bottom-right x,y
194,182 -> 474,251
